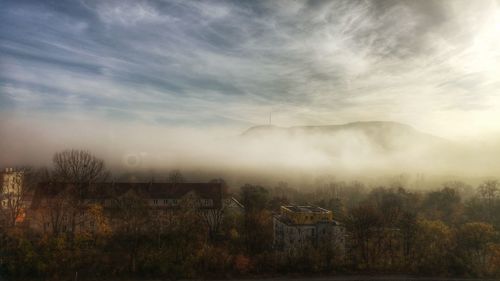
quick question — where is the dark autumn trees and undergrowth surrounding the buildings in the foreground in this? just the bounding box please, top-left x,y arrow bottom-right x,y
0,150 -> 500,280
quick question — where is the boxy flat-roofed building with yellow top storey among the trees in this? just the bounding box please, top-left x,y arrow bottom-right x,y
273,205 -> 345,253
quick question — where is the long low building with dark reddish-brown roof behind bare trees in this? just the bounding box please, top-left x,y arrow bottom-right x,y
28,182 -> 243,232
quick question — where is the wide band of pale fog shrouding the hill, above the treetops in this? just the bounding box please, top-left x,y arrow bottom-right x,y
0,118 -> 500,181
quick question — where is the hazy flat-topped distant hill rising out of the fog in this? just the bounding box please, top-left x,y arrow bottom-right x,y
242,121 -> 447,150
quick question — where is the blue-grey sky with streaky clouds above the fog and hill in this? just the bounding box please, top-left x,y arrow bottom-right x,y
0,0 -> 500,141
